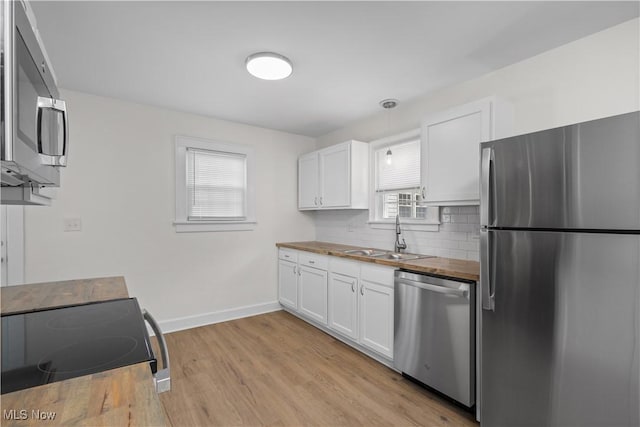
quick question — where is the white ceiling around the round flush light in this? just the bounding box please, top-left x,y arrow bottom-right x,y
32,1 -> 639,137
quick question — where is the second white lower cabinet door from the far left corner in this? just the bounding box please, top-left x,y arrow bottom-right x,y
298,265 -> 327,325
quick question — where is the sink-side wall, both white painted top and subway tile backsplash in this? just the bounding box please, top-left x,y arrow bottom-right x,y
316,19 -> 640,260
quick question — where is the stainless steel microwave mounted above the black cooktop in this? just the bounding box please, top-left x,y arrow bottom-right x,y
0,1 -> 69,204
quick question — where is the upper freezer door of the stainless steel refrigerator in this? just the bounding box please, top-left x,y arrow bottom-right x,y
480,112 -> 640,230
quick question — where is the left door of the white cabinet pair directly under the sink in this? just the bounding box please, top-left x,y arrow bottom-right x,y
329,273 -> 358,339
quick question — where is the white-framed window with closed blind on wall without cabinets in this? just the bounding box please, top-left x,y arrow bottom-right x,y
175,136 -> 255,232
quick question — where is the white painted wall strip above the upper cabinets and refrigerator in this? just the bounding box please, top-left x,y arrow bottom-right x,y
317,19 -> 640,148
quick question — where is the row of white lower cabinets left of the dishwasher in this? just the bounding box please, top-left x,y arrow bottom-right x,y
278,249 -> 395,363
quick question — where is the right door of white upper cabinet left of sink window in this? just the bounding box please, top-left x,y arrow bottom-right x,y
319,143 -> 351,208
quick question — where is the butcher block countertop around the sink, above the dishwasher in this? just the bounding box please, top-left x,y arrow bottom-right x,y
276,241 -> 480,282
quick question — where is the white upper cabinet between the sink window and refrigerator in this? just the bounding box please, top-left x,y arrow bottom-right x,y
421,97 -> 512,206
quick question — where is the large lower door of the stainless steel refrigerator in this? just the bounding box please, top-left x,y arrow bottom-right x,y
481,231 -> 640,427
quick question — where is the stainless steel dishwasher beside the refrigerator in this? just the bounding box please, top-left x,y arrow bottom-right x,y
393,270 -> 476,408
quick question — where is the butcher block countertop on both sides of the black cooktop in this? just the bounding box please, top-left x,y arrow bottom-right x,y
0,277 -> 168,426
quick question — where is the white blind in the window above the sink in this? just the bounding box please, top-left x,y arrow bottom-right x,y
376,140 -> 420,191
